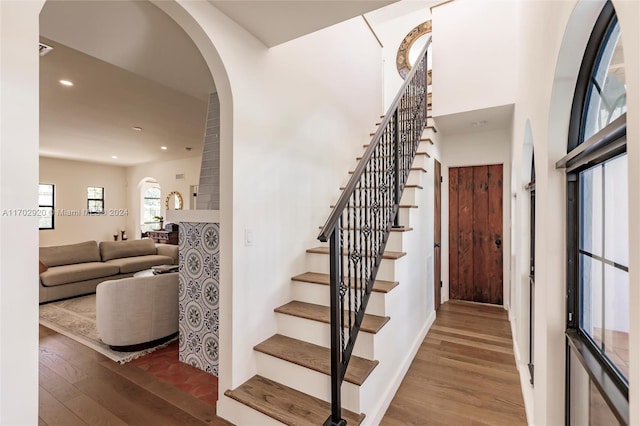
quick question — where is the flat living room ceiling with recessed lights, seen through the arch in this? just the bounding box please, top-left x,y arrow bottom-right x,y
40,39 -> 207,166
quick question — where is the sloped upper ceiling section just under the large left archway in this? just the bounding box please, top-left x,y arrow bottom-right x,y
40,0 -> 215,101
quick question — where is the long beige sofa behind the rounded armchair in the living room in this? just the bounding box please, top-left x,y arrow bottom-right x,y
40,239 -> 178,303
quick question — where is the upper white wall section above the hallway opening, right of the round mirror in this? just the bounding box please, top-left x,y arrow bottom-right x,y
432,0 -> 518,117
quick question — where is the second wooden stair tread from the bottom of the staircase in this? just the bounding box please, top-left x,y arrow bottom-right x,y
253,334 -> 378,386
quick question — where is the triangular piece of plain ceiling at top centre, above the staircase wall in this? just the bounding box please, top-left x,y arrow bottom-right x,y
208,0 -> 398,47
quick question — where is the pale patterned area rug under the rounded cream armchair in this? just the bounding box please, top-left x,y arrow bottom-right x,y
40,294 -> 175,364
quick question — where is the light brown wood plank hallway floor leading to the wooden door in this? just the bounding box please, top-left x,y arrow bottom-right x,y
381,301 -> 527,426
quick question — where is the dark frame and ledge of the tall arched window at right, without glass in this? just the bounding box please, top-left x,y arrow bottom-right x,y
556,1 -> 629,425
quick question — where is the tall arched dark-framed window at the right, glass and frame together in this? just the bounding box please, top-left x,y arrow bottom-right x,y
557,1 -> 629,425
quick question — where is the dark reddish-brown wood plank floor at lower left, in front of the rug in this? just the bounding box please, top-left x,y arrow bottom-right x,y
38,326 -> 230,426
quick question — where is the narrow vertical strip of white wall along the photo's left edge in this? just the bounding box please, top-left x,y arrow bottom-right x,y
0,1 -> 43,425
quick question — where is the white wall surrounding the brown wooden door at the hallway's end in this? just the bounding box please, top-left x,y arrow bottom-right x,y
439,129 -> 511,308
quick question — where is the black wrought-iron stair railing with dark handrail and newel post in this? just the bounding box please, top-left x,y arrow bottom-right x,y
318,37 -> 431,425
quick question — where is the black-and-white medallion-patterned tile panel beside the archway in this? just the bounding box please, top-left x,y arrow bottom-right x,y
178,222 -> 220,376
